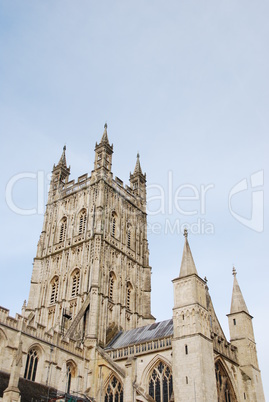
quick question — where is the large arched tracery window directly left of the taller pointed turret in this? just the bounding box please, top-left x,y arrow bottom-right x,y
149,361 -> 173,402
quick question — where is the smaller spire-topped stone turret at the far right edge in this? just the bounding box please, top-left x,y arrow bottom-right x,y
228,268 -> 265,402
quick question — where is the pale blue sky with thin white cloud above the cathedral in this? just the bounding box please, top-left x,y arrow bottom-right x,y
0,0 -> 269,399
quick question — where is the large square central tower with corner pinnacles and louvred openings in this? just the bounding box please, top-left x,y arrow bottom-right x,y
26,125 -> 154,345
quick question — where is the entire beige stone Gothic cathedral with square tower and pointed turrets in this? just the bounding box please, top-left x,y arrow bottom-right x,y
0,125 -> 265,402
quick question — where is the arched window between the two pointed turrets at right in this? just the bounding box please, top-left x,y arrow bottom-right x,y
215,361 -> 237,402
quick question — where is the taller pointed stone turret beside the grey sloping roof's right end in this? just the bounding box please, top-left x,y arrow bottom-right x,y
172,229 -> 217,402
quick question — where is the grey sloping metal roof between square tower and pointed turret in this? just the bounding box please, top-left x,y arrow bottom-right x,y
106,319 -> 173,349
